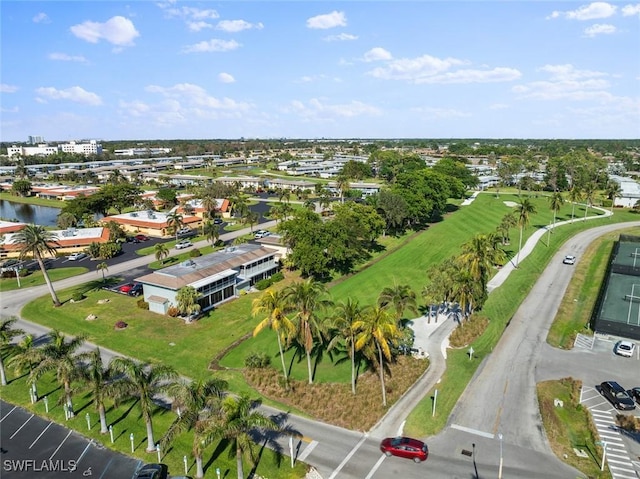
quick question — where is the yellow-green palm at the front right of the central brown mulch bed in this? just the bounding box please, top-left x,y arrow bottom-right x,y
353,306 -> 399,407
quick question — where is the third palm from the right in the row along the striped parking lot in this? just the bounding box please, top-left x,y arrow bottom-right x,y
111,357 -> 178,452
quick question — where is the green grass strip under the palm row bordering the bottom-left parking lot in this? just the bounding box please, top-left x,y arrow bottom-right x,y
2,371 -> 306,479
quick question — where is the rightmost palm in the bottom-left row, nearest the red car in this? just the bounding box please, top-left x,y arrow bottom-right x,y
204,395 -> 281,479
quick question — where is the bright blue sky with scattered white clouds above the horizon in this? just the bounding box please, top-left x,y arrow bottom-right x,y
0,0 -> 640,141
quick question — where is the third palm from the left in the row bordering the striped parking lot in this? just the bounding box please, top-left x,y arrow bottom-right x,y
29,330 -> 86,417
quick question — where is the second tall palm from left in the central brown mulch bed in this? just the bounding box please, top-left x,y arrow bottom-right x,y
285,278 -> 331,384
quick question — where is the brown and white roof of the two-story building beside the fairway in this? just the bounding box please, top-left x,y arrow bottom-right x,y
136,244 -> 277,291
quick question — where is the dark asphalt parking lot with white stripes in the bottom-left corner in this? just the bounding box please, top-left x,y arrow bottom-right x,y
0,401 -> 141,479
